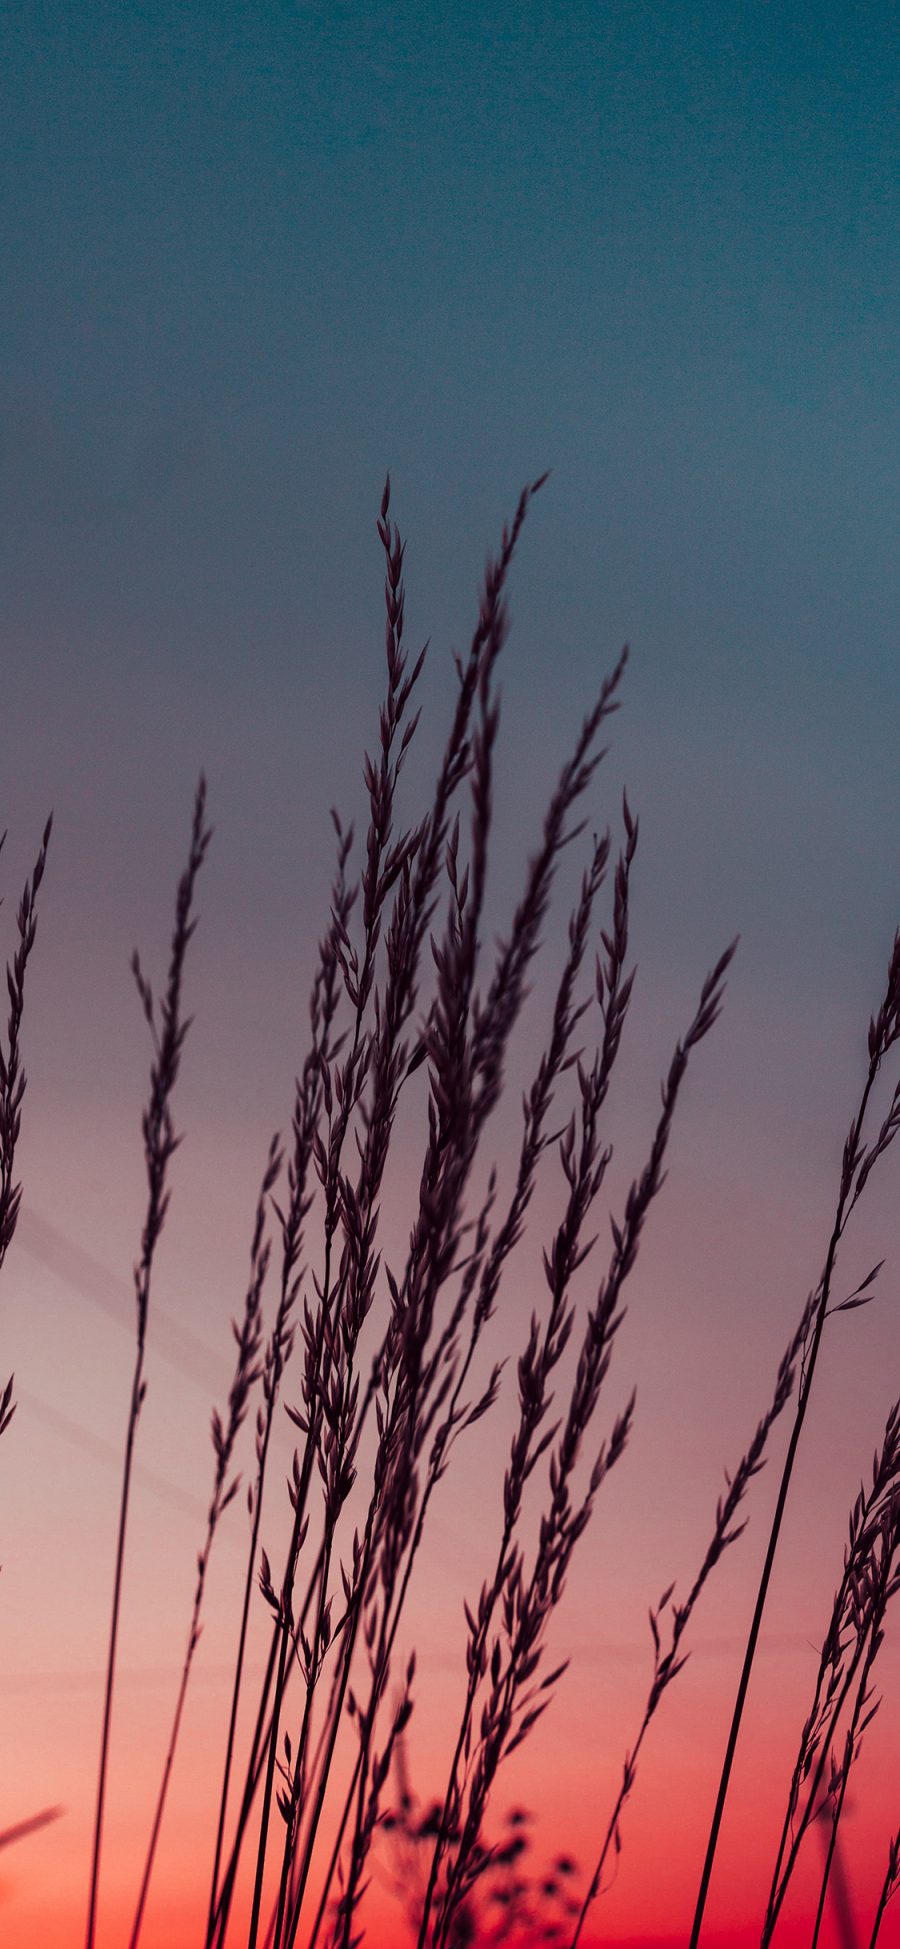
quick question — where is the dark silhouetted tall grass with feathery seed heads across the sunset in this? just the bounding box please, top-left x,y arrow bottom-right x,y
0,478 -> 900,1949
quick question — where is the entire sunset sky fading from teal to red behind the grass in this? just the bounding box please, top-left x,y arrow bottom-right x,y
0,0 -> 900,1949
